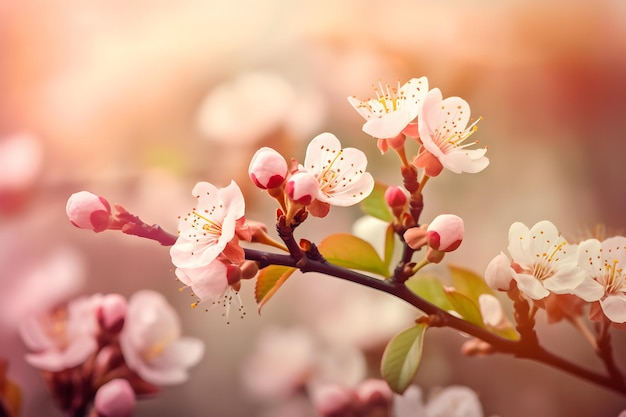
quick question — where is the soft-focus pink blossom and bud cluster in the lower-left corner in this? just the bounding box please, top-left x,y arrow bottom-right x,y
20,290 -> 204,417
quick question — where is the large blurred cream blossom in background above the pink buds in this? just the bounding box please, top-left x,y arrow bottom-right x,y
197,72 -> 324,145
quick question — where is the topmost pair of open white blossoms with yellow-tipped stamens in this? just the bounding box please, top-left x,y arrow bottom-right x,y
348,77 -> 489,177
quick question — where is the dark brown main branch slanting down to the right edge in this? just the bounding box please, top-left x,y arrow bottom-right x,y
244,249 -> 626,396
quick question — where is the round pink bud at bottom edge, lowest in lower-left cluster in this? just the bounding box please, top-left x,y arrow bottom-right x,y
94,378 -> 137,417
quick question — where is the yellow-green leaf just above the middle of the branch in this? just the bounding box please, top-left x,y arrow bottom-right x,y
318,233 -> 389,277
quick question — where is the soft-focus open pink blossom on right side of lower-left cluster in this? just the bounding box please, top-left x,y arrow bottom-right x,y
120,290 -> 204,385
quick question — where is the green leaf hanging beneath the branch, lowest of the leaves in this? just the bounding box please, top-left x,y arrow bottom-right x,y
380,323 -> 428,394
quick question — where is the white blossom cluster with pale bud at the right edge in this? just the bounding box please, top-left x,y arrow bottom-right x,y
485,220 -> 626,324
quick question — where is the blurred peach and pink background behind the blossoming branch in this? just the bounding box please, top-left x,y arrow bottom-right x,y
0,0 -> 626,417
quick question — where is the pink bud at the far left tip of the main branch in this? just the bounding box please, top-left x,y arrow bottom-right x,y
65,191 -> 112,232
